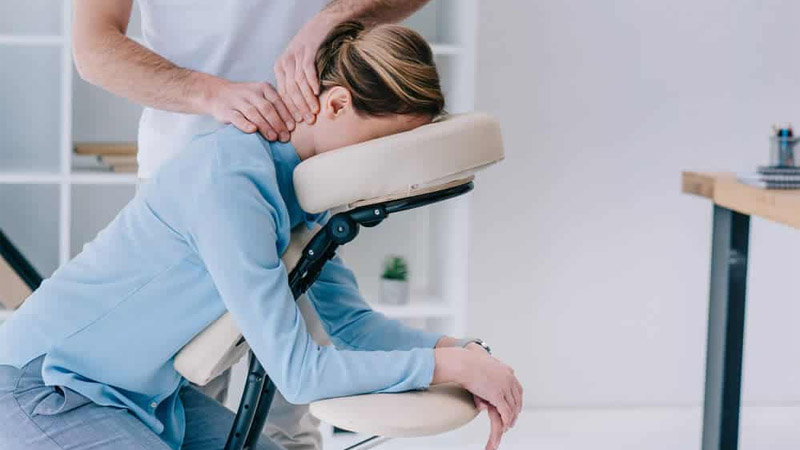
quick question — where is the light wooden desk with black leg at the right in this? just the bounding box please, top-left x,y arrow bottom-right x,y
683,172 -> 800,450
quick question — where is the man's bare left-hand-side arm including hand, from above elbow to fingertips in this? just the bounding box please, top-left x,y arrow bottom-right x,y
72,0 -> 296,141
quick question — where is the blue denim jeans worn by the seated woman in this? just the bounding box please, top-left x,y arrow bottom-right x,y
0,358 -> 281,450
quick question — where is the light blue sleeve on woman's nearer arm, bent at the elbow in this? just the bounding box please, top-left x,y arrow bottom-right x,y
188,159 -> 434,403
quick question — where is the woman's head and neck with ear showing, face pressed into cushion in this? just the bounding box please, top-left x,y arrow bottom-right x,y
292,21 -> 444,159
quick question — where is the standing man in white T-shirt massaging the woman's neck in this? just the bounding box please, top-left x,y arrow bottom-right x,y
73,0 -> 428,449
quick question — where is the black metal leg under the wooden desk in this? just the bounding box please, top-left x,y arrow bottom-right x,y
703,206 -> 750,450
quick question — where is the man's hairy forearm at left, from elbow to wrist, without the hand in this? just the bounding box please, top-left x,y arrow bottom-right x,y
75,30 -> 212,114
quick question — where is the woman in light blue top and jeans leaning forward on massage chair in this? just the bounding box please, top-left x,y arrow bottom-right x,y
0,22 -> 522,450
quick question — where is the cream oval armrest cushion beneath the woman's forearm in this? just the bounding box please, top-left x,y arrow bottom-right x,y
311,384 -> 478,438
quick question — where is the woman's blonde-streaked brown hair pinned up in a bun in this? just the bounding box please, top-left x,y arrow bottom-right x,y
316,21 -> 444,118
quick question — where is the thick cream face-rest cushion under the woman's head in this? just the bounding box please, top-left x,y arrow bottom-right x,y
294,113 -> 503,213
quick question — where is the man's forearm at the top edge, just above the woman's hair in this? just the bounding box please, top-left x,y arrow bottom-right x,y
323,0 -> 429,24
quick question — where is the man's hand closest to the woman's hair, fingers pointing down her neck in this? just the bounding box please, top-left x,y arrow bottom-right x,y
274,12 -> 336,124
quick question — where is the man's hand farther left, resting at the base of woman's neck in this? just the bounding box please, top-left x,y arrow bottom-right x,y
202,76 -> 295,142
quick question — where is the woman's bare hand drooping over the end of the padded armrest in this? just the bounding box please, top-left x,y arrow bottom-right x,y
433,348 -> 523,449
